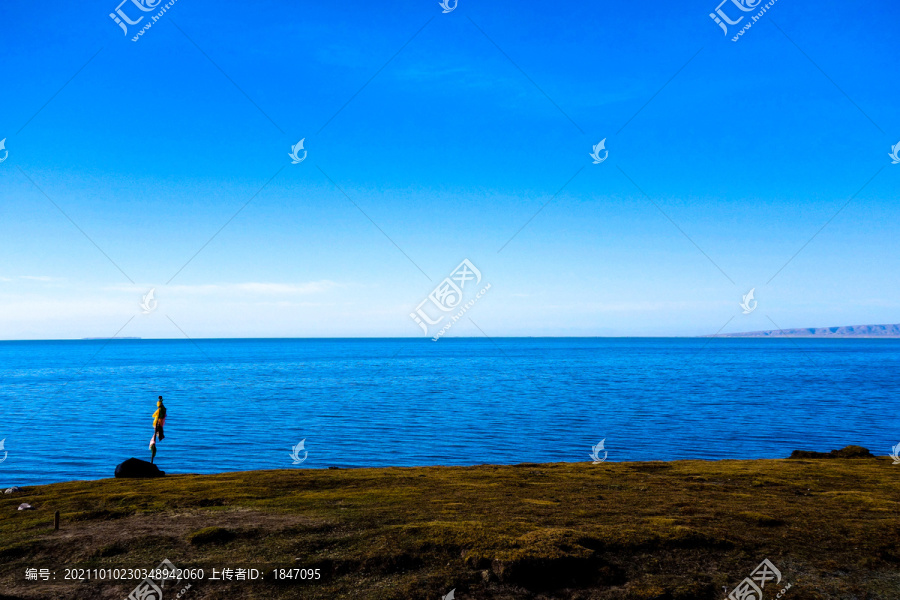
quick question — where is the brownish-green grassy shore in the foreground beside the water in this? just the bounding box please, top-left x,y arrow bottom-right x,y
0,458 -> 900,600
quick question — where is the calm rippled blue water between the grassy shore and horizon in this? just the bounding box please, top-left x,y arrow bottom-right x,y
0,338 -> 900,486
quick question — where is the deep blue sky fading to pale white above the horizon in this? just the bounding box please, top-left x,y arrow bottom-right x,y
0,0 -> 900,339
